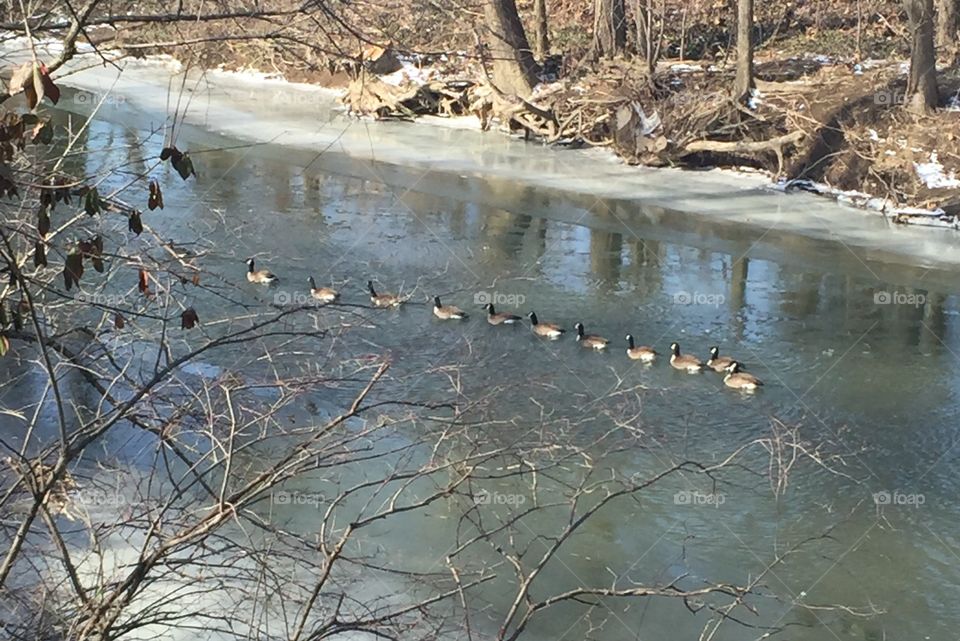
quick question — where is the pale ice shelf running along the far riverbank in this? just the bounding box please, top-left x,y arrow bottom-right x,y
5,34 -> 960,276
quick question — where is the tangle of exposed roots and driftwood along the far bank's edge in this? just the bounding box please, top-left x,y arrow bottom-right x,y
343,60 -> 807,178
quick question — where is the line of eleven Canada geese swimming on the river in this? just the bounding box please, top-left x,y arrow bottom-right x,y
247,258 -> 763,392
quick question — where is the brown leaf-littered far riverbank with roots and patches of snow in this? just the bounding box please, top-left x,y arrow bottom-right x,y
0,0 -> 960,230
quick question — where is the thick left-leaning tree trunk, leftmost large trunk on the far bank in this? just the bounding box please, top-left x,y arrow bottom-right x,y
484,0 -> 537,98
